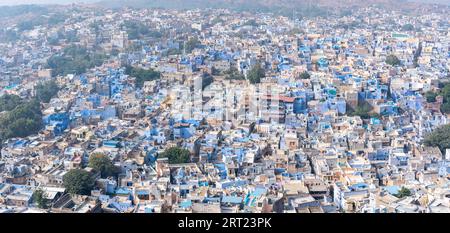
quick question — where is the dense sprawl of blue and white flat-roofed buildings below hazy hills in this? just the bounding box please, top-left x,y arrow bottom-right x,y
0,1 -> 450,213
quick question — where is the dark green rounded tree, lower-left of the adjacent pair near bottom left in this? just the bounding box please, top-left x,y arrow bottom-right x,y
63,169 -> 95,195
